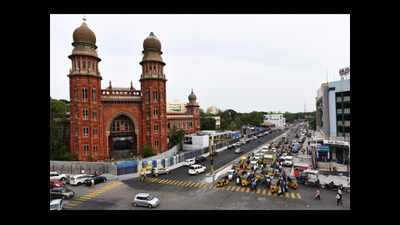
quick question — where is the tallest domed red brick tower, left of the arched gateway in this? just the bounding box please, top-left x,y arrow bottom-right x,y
68,18 -> 102,160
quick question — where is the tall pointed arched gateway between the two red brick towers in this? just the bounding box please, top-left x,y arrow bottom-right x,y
106,112 -> 139,159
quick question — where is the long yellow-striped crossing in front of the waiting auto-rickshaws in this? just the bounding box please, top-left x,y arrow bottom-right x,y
146,178 -> 302,199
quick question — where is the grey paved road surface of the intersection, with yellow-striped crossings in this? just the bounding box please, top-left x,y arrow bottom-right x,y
60,124 -> 350,210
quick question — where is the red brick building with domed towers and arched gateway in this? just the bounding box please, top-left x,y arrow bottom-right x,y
68,18 -> 200,161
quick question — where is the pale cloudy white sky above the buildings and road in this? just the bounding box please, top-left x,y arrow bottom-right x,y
50,14 -> 350,112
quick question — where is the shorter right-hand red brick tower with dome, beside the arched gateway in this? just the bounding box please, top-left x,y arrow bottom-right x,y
140,32 -> 168,153
